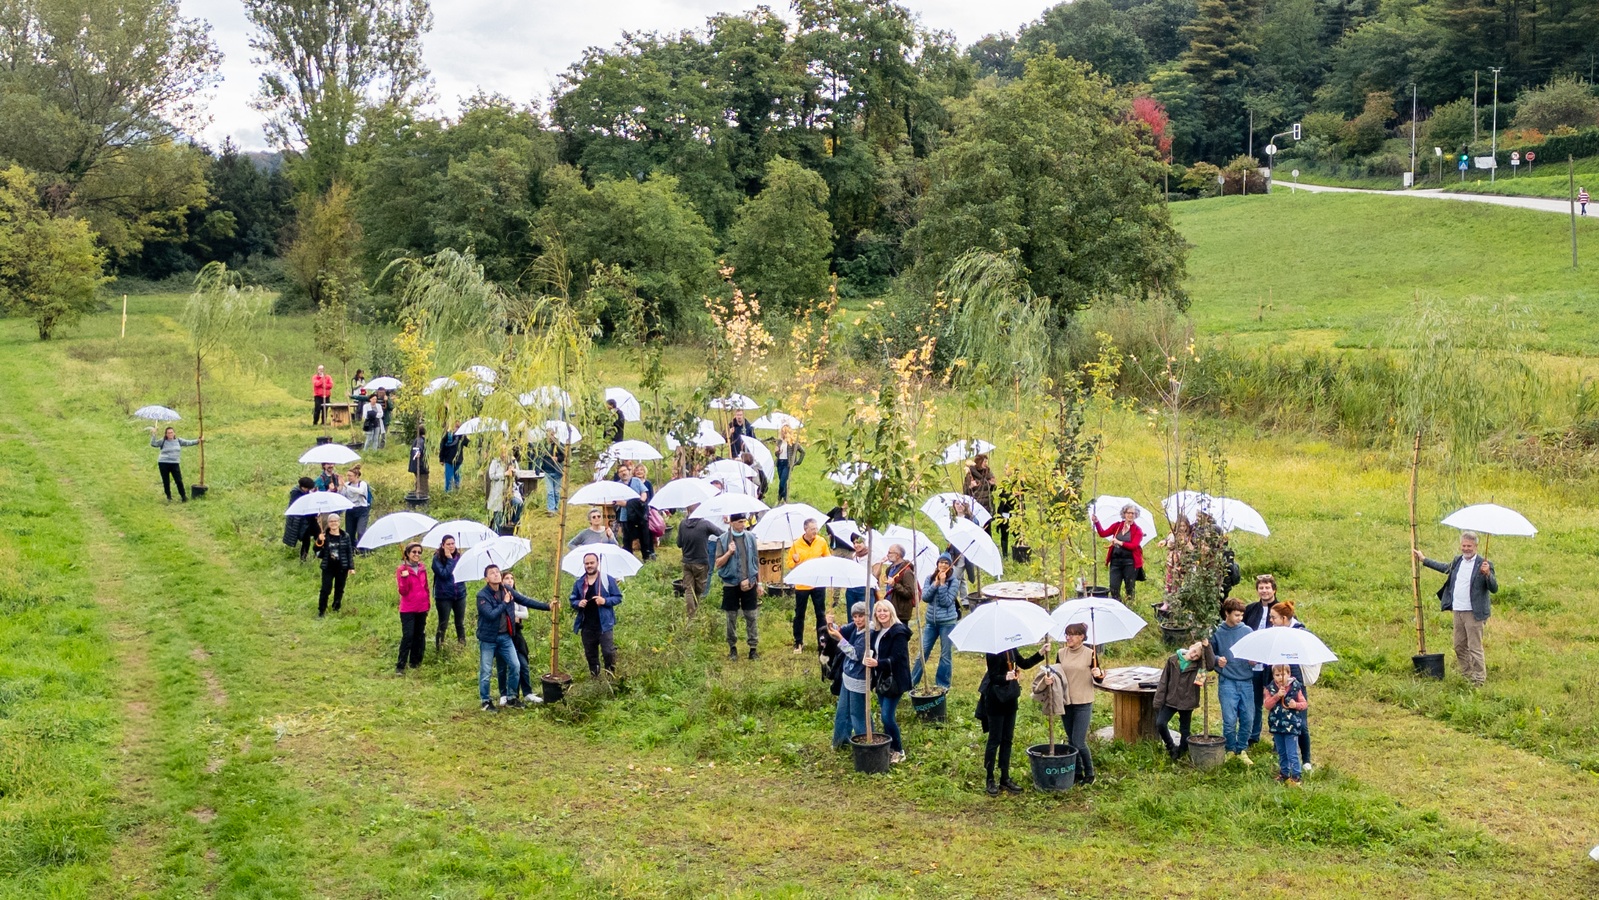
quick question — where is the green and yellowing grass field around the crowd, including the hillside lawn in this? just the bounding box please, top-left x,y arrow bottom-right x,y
9,193 -> 1599,898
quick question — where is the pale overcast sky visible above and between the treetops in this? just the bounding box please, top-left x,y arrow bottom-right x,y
181,0 -> 1054,150
